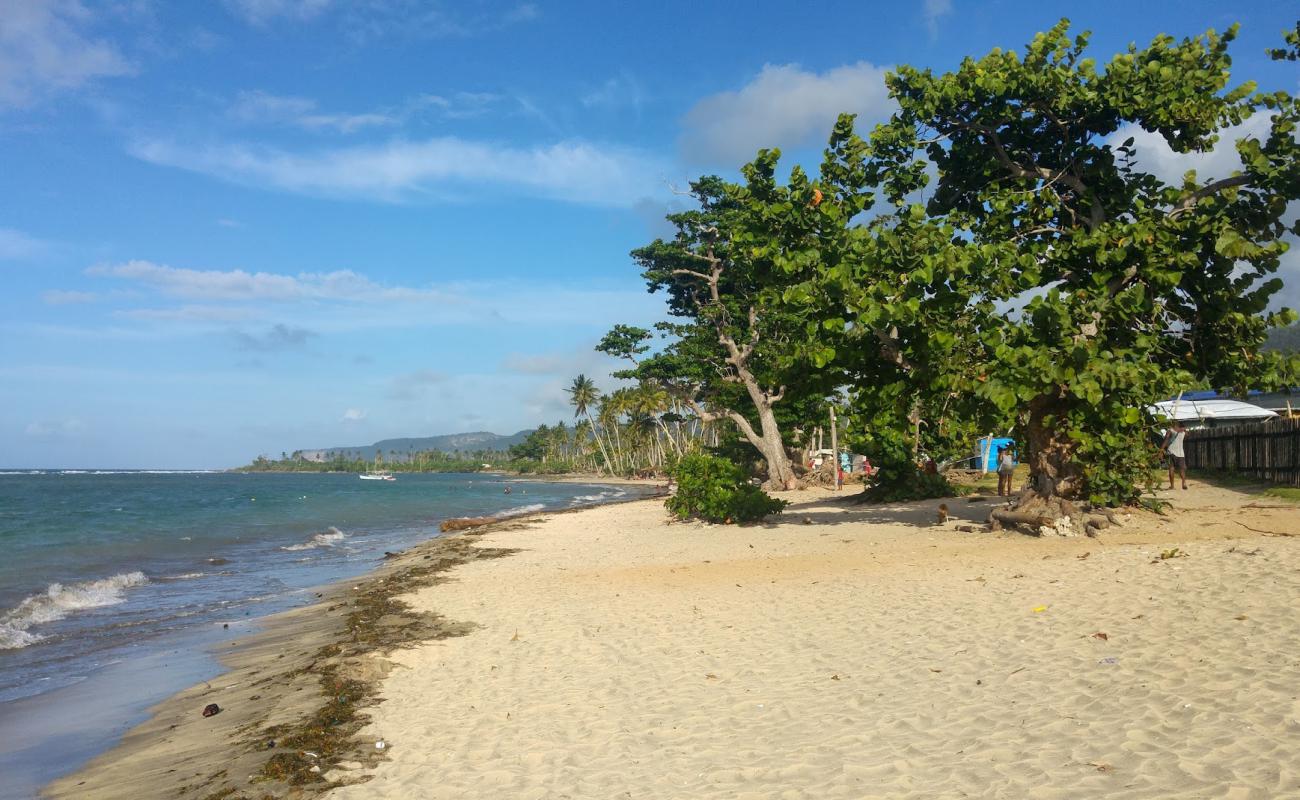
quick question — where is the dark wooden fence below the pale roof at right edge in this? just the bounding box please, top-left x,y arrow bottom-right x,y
1183,419 -> 1300,487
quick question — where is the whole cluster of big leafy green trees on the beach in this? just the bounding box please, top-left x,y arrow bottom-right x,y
593,20 -> 1300,528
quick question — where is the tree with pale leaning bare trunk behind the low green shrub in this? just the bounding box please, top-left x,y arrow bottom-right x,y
598,166 -> 836,489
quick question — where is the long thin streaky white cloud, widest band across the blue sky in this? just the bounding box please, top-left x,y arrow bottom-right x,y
131,137 -> 666,206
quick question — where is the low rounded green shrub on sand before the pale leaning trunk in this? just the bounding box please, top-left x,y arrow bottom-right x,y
667,454 -> 789,524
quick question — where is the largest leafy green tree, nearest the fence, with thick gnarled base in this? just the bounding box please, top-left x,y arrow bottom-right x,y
871,21 -> 1300,519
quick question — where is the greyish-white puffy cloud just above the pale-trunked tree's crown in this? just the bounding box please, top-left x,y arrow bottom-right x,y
679,61 -> 893,167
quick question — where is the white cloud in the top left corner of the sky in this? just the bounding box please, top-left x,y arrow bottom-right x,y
0,0 -> 131,109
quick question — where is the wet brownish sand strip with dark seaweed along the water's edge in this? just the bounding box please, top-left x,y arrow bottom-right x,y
38,489 -> 658,800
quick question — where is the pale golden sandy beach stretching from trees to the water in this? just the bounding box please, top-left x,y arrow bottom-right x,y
49,485 -> 1300,800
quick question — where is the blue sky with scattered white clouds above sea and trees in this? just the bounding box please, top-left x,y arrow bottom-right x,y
0,0 -> 1300,468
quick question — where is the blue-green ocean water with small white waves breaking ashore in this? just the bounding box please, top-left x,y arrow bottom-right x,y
0,470 -> 645,797
